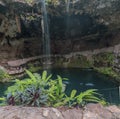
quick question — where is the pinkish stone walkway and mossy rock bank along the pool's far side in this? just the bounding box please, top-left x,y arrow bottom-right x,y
1,44 -> 120,77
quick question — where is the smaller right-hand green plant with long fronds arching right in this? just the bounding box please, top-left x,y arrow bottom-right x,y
64,89 -> 106,107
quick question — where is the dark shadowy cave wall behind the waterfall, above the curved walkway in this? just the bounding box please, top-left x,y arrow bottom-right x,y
0,0 -> 120,60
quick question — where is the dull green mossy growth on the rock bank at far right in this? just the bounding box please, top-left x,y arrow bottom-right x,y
93,52 -> 119,80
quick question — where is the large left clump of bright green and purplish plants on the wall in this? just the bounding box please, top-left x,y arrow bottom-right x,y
3,70 -> 64,106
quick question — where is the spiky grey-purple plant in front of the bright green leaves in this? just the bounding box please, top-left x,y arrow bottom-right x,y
7,87 -> 48,107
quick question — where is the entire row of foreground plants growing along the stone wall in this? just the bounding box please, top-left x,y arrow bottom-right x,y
1,70 -> 105,107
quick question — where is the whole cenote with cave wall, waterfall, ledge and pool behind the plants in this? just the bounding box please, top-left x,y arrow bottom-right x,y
0,0 -> 120,109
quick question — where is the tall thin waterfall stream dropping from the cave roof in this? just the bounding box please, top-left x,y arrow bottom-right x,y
41,0 -> 51,68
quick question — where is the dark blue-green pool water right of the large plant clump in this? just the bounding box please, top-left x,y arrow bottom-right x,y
47,68 -> 120,104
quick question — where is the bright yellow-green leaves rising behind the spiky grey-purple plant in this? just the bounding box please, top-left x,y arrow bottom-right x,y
6,70 -> 52,95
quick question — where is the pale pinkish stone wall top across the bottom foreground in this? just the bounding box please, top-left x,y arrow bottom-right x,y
0,104 -> 120,119
